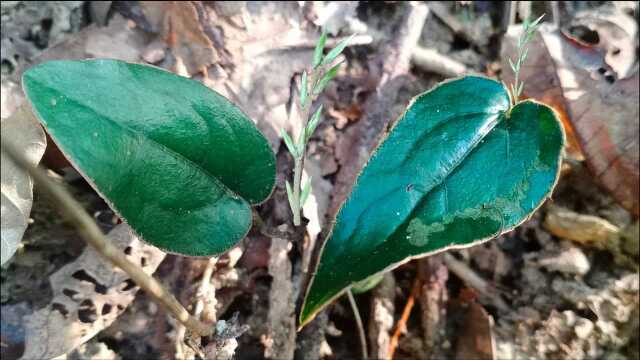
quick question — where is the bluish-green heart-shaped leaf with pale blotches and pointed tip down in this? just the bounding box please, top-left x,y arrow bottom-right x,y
300,76 -> 564,325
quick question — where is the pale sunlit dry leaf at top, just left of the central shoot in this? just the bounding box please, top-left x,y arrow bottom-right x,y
216,2 -> 313,152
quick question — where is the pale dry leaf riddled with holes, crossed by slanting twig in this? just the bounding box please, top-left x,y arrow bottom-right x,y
22,224 -> 165,359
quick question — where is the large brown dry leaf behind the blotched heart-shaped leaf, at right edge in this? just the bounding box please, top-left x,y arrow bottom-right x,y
502,24 -> 640,216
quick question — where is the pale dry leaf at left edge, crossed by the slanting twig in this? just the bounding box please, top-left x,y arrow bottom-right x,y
0,106 -> 46,264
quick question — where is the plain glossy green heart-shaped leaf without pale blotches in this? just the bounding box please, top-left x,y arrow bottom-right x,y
23,60 -> 275,256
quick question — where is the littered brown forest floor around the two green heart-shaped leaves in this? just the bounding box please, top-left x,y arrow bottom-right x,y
0,1 -> 640,359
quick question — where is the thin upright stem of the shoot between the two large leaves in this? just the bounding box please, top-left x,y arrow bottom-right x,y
291,66 -> 324,226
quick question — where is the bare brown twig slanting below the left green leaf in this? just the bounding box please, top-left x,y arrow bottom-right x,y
2,137 -> 214,336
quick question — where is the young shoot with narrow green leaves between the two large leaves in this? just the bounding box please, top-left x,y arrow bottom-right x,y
282,31 -> 353,226
